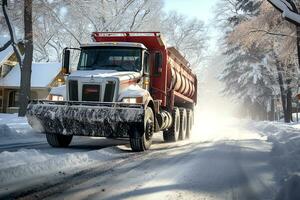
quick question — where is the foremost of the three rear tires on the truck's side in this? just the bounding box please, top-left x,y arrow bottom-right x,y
163,108 -> 180,142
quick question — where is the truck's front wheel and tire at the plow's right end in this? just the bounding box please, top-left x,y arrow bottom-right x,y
129,107 -> 154,152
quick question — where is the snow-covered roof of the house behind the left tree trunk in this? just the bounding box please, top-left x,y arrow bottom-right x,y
0,63 -> 61,88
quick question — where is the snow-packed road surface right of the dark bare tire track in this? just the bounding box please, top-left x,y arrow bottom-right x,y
49,140 -> 274,199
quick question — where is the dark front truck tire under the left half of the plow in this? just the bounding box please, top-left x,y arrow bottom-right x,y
46,133 -> 73,147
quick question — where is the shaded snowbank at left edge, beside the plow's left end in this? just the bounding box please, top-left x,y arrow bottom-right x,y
0,114 -> 45,144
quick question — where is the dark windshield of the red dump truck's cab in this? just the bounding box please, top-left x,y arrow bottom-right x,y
78,47 -> 142,71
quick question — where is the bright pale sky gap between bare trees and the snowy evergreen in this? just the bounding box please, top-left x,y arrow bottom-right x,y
164,0 -> 234,112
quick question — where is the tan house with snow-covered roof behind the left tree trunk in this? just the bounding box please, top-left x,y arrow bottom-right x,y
0,37 -> 64,113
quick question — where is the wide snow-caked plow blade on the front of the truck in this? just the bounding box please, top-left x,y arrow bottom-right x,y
26,100 -> 145,138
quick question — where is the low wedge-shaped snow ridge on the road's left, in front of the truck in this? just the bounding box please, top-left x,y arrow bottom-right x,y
0,148 -> 128,184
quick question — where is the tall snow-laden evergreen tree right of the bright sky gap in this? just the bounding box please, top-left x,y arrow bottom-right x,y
216,0 -> 274,119
